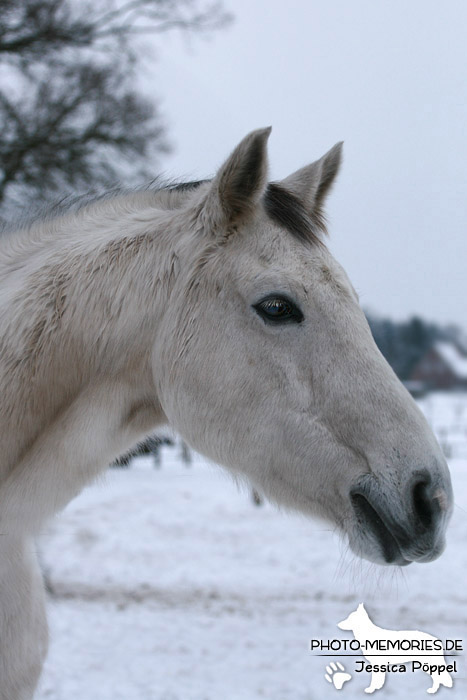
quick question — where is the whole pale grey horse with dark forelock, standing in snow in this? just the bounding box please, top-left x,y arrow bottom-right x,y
0,129 -> 452,700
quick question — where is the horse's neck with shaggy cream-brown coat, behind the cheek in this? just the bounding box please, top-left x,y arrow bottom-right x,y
0,194 -> 191,474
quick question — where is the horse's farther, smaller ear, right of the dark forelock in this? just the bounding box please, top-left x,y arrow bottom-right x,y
280,141 -> 342,218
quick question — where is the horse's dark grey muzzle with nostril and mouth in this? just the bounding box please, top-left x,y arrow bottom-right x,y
349,470 -> 452,566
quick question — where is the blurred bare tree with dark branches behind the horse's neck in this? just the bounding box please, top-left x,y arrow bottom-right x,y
0,0 -> 230,209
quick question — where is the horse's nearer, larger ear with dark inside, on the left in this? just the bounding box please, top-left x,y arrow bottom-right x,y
206,127 -> 271,224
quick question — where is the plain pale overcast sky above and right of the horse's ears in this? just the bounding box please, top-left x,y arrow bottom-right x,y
145,0 -> 467,329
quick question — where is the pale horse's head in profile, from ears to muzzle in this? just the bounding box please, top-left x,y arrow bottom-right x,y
153,129 -> 452,565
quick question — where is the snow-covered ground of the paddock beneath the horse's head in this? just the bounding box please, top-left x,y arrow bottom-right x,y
36,395 -> 467,700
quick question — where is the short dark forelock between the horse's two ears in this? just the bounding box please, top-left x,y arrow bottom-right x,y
263,182 -> 326,245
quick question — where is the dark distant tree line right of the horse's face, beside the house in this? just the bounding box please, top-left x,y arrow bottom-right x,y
366,312 -> 464,380
